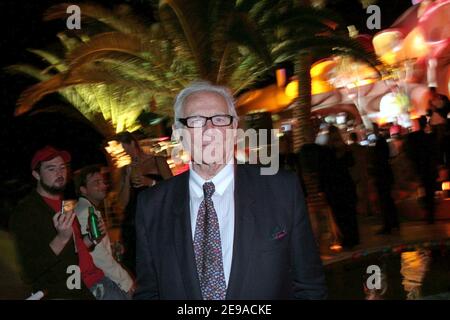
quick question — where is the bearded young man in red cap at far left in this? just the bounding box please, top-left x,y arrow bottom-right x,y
10,146 -> 94,299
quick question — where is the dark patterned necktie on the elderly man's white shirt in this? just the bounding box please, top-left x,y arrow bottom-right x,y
194,182 -> 227,300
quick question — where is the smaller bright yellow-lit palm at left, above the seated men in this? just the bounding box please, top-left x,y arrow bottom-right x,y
7,34 -> 151,137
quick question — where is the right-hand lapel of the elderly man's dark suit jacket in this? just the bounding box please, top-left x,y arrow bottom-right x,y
226,165 -> 256,300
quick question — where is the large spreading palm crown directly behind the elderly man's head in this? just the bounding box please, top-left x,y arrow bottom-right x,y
9,0 -> 271,135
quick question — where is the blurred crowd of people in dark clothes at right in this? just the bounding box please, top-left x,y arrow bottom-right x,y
280,88 -> 450,249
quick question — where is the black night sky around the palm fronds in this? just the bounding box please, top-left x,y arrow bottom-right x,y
0,0 -> 411,210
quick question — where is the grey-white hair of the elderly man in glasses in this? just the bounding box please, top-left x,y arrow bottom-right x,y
173,81 -> 239,128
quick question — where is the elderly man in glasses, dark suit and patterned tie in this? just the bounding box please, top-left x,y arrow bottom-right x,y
135,82 -> 327,300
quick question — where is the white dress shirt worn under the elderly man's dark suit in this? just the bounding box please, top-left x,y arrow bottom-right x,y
189,164 -> 234,287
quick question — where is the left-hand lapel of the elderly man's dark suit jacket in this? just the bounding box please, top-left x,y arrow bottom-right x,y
172,171 -> 202,300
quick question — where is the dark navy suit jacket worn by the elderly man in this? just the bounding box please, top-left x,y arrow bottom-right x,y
135,165 -> 326,300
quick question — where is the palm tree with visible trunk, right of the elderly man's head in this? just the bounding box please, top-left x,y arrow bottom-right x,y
250,0 -> 381,152
